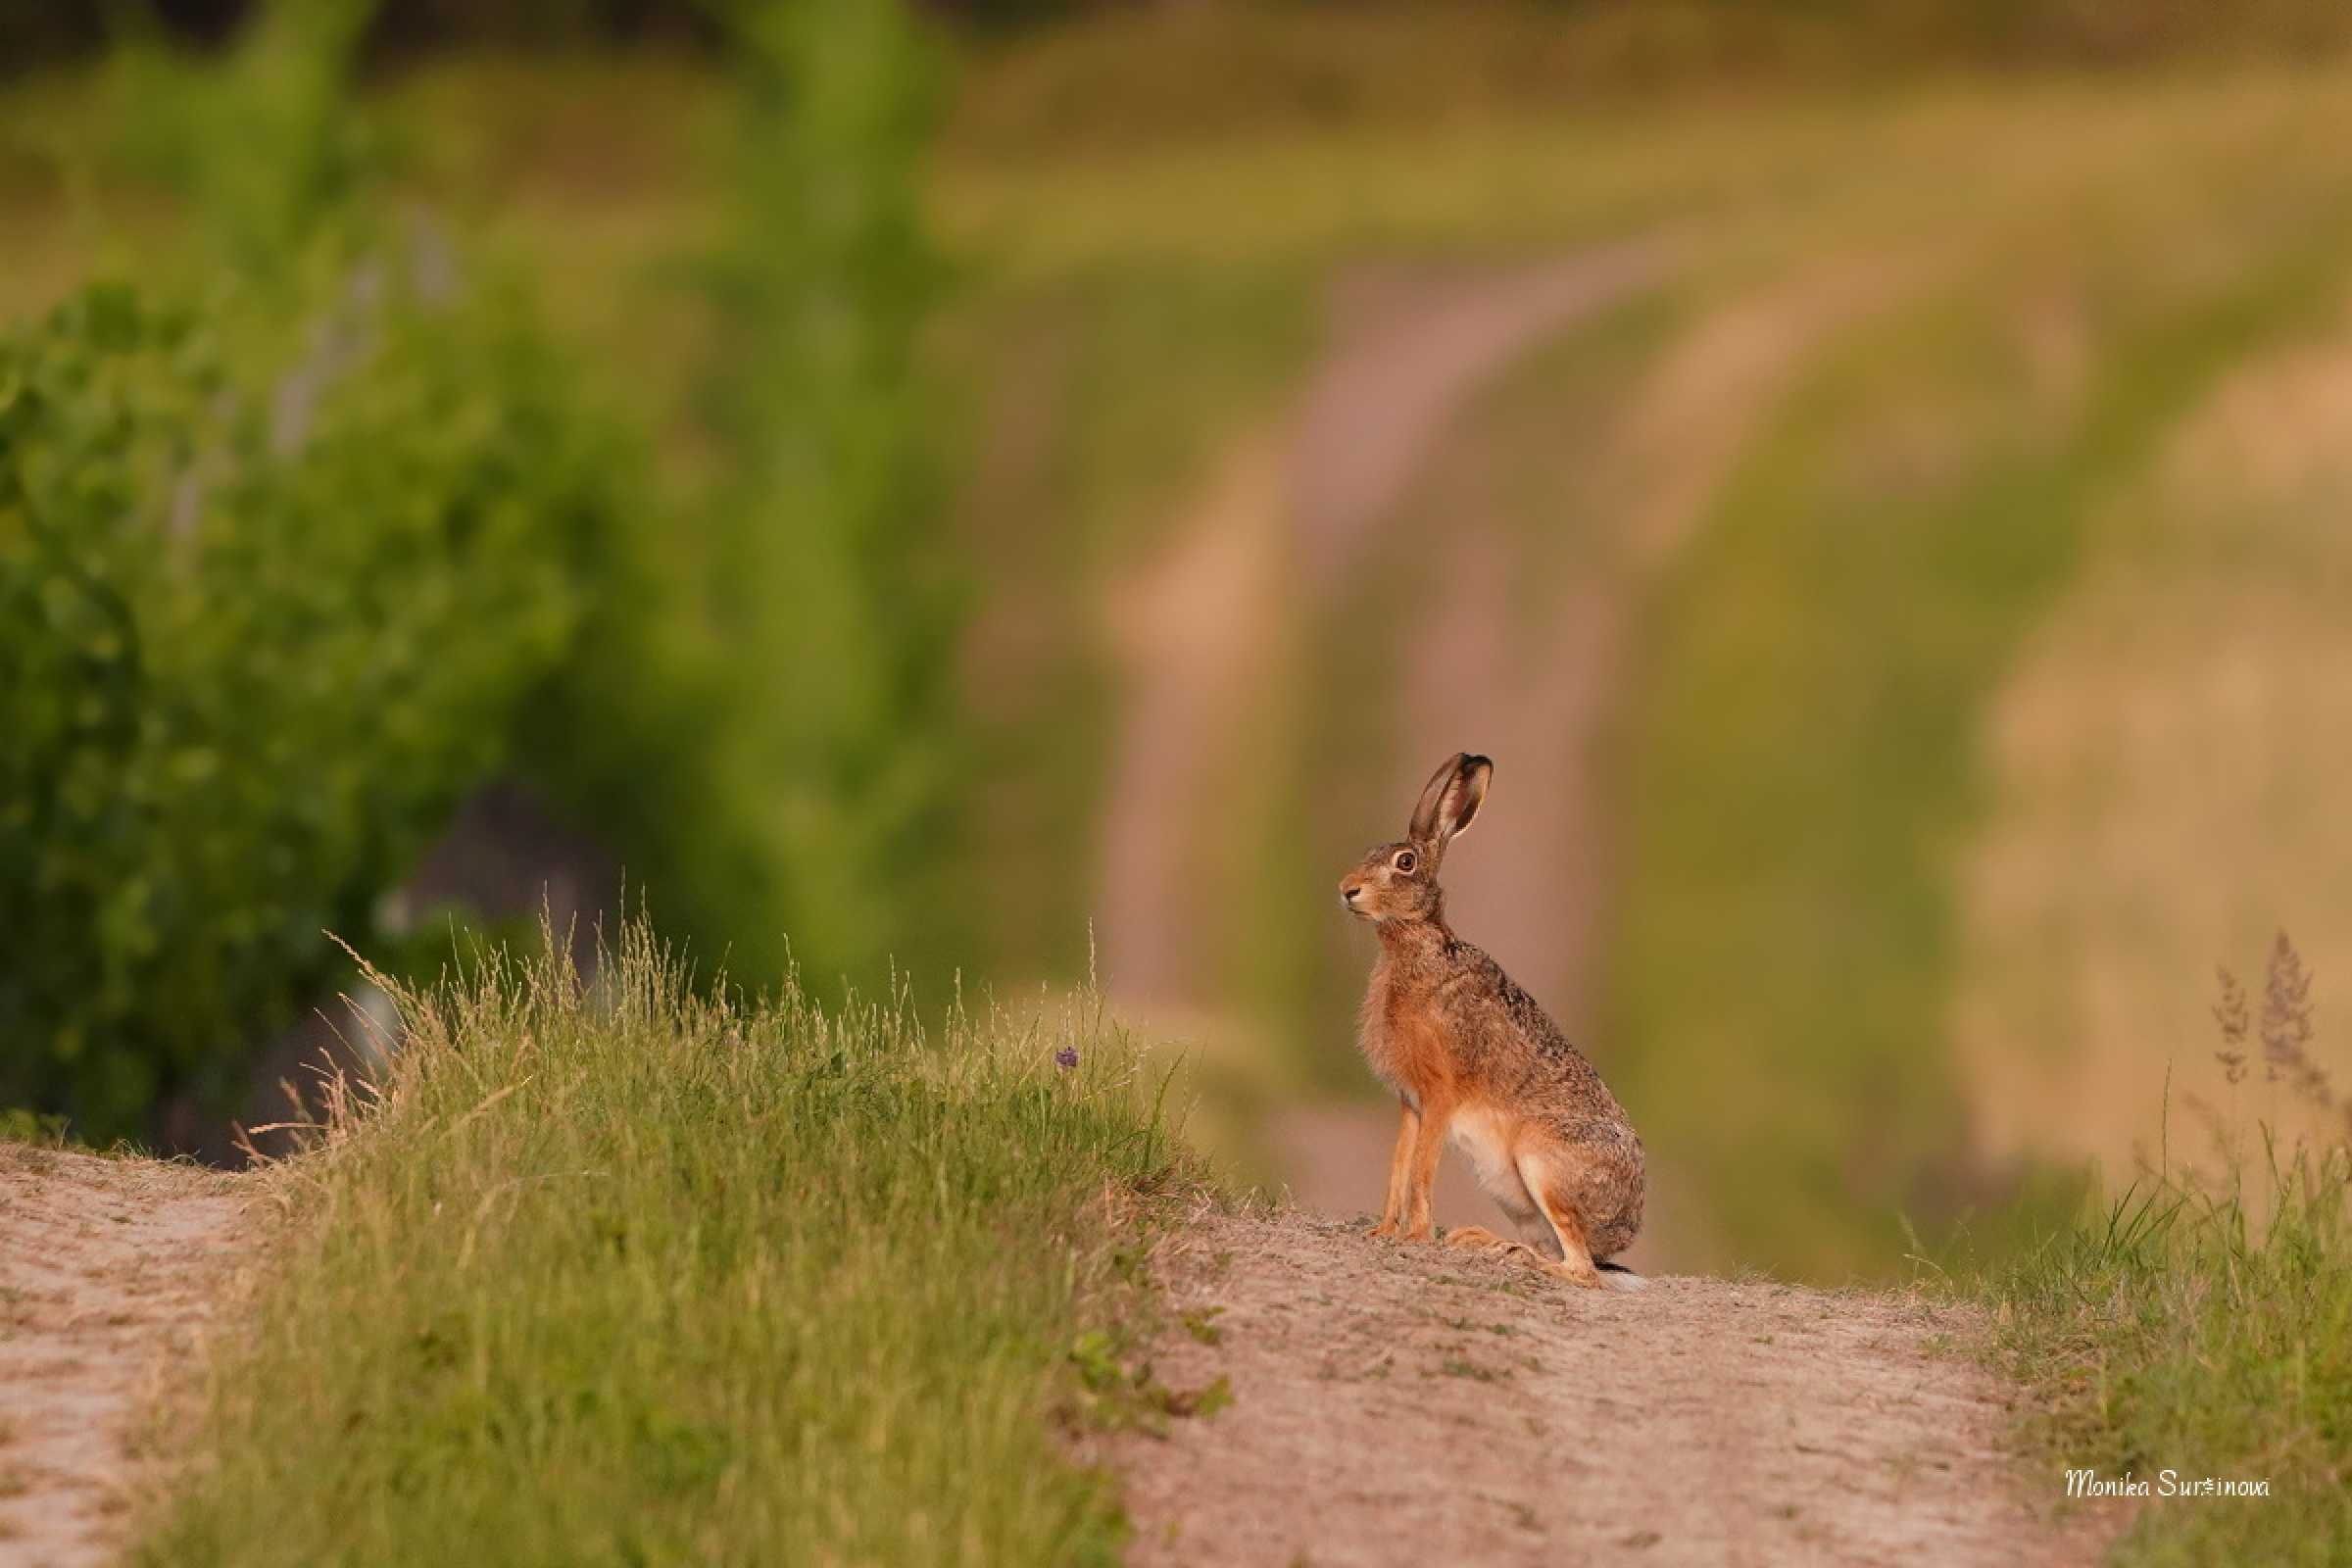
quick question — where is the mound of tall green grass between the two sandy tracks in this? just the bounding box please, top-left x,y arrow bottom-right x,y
136,933 -> 1216,1568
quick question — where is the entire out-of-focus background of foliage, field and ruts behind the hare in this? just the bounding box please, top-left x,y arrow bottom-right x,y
0,0 -> 2352,1279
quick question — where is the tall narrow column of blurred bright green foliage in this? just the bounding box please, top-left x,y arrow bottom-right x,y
682,0 -> 959,1001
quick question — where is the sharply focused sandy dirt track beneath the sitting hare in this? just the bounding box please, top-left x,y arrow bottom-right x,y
1107,1210 -> 2122,1568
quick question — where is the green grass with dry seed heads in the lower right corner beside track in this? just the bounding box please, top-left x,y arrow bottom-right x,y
1978,938 -> 2352,1563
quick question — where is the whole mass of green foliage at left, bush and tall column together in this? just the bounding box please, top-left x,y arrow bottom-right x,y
0,0 -> 957,1138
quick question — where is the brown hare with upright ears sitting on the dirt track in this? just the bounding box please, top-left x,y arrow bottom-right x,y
1339,753 -> 1642,1289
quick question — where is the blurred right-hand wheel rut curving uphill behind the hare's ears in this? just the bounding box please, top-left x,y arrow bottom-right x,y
1399,261 -> 1888,1020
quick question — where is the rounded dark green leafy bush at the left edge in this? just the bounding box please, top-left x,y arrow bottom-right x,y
0,264 -> 605,1138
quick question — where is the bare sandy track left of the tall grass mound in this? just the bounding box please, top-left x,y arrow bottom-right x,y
0,1145 -> 242,1568
